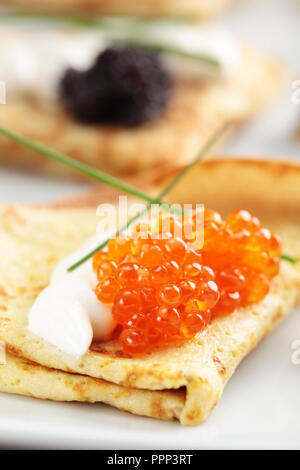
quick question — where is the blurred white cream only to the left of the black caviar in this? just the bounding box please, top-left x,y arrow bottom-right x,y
0,26 -> 105,105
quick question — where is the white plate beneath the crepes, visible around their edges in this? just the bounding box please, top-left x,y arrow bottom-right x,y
0,0 -> 300,449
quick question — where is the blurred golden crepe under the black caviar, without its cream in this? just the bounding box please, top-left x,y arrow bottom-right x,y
0,45 -> 282,181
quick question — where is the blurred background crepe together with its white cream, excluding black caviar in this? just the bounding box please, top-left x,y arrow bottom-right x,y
0,19 -> 283,182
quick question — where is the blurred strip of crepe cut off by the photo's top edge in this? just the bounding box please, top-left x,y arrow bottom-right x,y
1,0 -> 238,18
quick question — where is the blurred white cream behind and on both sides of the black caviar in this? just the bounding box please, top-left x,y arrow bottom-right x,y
0,20 -> 240,105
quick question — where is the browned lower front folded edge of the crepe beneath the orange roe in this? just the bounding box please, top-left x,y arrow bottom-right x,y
0,353 -> 185,421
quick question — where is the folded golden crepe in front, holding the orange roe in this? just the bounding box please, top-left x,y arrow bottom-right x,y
0,159 -> 300,425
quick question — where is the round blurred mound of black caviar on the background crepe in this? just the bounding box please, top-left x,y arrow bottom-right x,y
60,46 -> 171,126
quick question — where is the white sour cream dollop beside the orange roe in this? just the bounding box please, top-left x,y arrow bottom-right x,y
28,236 -> 115,356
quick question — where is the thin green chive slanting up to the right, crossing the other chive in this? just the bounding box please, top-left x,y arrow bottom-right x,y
68,122 -> 231,272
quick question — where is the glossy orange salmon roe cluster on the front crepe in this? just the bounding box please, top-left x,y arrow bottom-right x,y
93,209 -> 281,356
